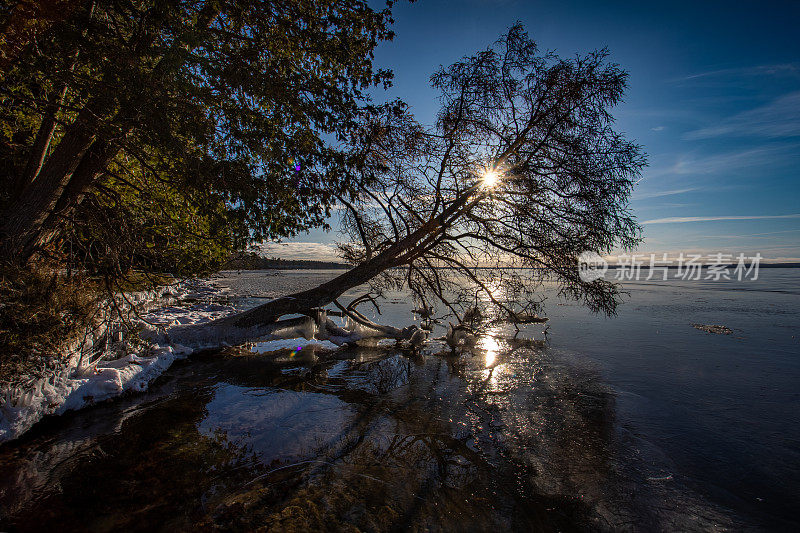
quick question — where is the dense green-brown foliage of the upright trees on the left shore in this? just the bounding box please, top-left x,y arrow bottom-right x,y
0,0 -> 400,275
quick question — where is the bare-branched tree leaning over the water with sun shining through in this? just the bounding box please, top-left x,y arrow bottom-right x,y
168,24 -> 645,345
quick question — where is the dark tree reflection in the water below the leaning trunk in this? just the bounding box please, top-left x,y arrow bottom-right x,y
0,332 -> 736,531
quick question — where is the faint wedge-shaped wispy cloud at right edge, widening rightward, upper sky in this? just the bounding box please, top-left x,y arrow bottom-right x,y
684,91 -> 800,140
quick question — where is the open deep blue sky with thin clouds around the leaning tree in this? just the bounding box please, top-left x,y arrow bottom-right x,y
269,0 -> 800,261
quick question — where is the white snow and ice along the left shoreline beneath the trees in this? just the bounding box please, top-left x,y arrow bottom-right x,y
0,274 -> 412,443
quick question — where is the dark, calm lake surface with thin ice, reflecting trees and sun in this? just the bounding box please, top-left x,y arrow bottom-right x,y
0,269 -> 800,531
